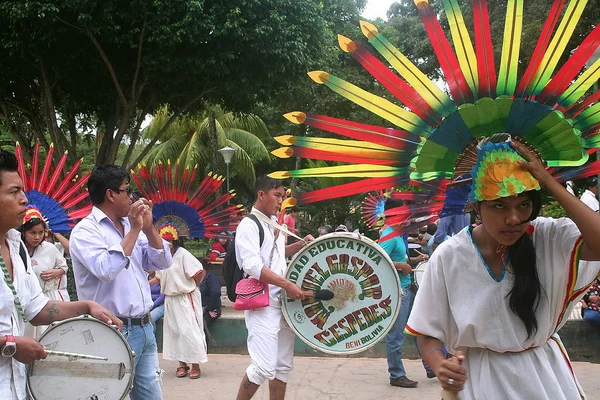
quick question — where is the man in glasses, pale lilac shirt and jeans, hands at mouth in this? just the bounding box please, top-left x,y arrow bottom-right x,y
70,165 -> 172,400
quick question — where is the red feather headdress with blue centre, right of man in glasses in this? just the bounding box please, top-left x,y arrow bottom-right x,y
131,162 -> 243,240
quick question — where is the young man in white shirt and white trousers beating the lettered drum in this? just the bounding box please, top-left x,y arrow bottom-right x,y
235,176 -> 314,400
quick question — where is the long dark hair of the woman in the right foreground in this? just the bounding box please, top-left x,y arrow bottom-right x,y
507,190 -> 542,338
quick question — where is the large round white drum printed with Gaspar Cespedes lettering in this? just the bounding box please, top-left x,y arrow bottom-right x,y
282,232 -> 401,355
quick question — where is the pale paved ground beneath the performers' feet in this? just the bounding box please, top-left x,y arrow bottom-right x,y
161,354 -> 600,400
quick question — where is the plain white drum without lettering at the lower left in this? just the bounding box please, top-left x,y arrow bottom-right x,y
27,315 -> 134,400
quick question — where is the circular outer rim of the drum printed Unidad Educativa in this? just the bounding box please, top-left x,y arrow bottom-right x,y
281,232 -> 402,356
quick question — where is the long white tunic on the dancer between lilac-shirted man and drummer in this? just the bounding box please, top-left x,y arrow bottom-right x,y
156,247 -> 208,363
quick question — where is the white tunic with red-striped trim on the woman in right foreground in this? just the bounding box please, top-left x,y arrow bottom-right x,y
406,218 -> 599,400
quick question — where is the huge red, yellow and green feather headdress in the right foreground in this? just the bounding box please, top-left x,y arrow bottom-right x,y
271,0 -> 600,228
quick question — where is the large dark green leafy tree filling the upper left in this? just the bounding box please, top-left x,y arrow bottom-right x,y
0,0 -> 327,166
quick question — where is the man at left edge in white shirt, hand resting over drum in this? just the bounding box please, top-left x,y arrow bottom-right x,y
0,149 -> 122,400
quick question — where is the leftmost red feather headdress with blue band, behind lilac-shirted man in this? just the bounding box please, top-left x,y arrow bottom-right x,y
15,141 -> 92,232
